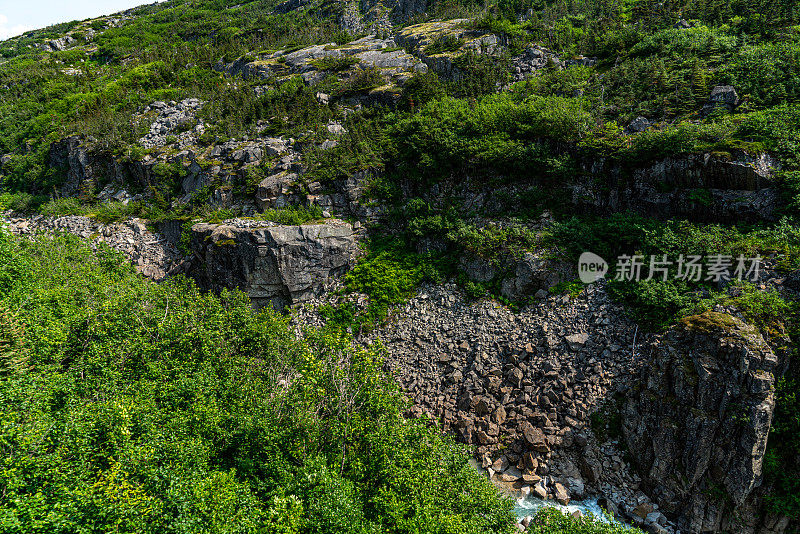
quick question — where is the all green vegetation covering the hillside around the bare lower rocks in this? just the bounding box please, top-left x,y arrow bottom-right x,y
0,0 -> 800,534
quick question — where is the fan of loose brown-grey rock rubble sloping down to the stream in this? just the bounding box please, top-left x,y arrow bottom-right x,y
295,284 -> 679,532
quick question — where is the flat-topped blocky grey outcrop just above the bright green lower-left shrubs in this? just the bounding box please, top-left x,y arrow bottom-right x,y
190,220 -> 357,309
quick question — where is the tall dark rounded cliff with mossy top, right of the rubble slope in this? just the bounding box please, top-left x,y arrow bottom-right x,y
623,312 -> 777,533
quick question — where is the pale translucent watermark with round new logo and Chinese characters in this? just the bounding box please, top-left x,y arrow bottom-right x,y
578,252 -> 761,284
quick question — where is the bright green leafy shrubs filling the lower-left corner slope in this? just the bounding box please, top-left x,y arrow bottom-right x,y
0,233 -> 513,533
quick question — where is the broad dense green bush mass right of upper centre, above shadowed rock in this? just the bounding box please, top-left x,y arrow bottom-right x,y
391,93 -> 592,182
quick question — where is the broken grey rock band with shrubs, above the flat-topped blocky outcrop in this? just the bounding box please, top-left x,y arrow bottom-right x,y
44,118 -> 380,219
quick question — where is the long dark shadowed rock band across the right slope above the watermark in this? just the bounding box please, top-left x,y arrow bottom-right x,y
404,150 -> 782,223
